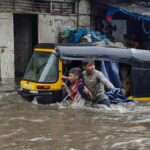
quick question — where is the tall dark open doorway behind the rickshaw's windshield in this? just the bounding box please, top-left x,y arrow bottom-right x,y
14,14 -> 38,79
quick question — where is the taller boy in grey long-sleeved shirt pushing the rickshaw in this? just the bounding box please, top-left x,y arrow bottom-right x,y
82,60 -> 114,107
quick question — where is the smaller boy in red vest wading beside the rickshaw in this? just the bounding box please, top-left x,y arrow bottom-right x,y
63,68 -> 92,102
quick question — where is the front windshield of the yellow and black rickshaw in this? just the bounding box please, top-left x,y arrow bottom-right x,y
23,52 -> 58,83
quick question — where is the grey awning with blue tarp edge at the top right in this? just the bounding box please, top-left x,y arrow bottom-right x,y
95,0 -> 150,21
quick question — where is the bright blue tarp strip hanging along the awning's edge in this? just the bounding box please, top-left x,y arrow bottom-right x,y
107,7 -> 150,21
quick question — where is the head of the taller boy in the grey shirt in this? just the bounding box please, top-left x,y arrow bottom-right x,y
82,59 -> 95,74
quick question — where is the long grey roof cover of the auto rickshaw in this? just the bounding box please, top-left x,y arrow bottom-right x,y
56,45 -> 150,62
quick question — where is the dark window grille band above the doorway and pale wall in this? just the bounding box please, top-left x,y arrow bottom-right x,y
0,0 -> 75,14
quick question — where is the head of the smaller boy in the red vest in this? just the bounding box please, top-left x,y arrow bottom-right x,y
69,68 -> 82,83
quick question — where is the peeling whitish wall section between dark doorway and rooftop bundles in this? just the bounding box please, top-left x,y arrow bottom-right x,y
38,14 -> 76,43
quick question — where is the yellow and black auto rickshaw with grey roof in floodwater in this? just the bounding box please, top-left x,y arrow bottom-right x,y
18,43 -> 150,104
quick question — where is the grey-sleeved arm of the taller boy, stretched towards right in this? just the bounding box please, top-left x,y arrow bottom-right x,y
99,72 -> 115,89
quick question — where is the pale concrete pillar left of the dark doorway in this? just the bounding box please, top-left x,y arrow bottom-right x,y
0,13 -> 15,83
